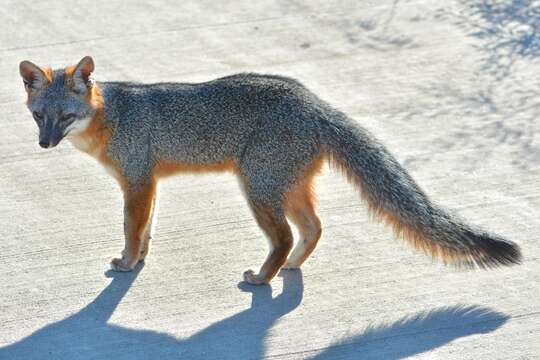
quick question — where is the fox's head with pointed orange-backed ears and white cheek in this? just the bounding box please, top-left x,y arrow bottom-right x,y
19,56 -> 97,148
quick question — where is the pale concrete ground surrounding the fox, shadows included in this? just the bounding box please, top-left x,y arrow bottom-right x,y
0,0 -> 540,360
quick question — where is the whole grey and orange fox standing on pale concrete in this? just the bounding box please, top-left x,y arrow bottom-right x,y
20,56 -> 521,284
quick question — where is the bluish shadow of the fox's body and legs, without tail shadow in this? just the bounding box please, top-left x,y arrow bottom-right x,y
0,264 -> 303,360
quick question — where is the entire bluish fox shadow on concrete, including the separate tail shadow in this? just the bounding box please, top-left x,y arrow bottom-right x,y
0,266 -> 508,360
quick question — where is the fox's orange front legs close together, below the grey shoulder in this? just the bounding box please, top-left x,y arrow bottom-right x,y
111,182 -> 156,271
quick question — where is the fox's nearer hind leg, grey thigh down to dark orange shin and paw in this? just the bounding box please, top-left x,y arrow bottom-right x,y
238,125 -> 321,284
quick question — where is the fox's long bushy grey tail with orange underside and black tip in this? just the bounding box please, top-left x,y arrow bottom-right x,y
321,114 -> 521,268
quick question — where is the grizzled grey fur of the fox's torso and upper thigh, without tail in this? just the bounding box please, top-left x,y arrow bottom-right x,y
98,74 -> 321,207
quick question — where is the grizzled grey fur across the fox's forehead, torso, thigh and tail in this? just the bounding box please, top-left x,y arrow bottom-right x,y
23,66 -> 521,266
